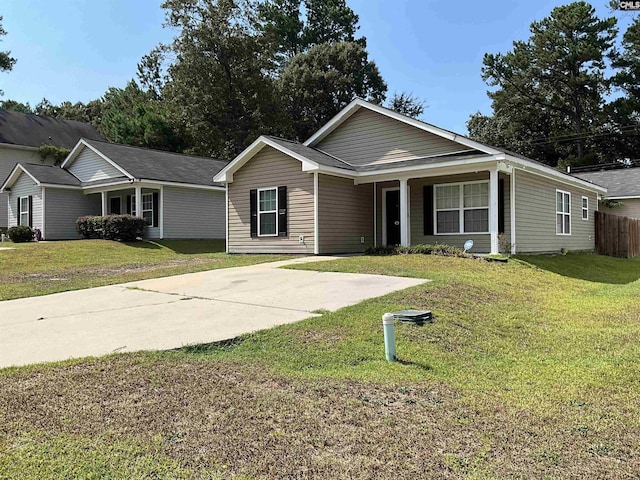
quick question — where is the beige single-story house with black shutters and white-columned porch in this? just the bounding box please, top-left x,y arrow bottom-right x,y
214,99 -> 606,254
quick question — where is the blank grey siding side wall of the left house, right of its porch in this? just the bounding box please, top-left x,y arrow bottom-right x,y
161,186 -> 226,239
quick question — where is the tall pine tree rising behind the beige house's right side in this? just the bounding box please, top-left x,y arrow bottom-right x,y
469,1 -> 617,165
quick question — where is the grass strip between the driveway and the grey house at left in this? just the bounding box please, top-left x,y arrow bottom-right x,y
0,240 -> 287,300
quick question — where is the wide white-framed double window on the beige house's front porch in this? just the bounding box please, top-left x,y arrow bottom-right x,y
433,180 -> 489,235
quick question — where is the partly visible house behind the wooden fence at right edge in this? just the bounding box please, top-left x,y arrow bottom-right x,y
572,165 -> 640,218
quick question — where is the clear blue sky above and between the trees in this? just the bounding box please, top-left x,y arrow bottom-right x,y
0,0 -> 634,133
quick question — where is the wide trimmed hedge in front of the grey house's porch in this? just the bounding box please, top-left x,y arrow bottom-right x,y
76,215 -> 146,242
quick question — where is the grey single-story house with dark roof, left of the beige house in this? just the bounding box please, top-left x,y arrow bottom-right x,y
0,139 -> 227,240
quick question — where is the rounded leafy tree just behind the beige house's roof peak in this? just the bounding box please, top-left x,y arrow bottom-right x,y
277,42 -> 387,140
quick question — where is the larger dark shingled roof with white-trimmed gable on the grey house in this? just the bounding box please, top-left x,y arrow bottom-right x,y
62,138 -> 228,186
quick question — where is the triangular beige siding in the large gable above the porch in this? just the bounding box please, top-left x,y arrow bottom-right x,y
315,108 -> 476,165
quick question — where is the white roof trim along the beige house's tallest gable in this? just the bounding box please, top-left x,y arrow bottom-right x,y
303,98 -> 502,155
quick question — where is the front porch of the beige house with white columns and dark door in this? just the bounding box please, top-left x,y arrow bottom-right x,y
358,163 -> 515,254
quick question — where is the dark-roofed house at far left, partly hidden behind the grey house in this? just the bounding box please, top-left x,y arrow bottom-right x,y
0,109 -> 104,229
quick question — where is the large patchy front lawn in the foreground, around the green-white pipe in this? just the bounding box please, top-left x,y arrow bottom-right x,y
0,255 -> 640,479
